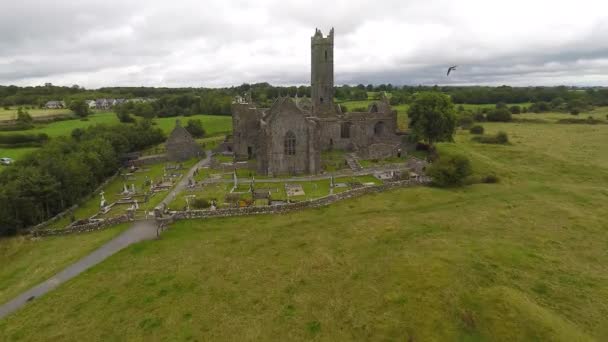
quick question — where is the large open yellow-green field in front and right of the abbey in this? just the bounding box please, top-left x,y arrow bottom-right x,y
0,114 -> 608,341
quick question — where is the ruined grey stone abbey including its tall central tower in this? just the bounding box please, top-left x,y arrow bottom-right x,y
232,29 -> 402,176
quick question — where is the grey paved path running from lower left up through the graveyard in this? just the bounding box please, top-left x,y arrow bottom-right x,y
0,152 -> 211,319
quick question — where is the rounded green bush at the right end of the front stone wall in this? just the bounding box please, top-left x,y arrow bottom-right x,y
427,155 -> 472,187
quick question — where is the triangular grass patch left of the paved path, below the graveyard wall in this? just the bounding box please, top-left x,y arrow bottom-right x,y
0,225 -> 127,304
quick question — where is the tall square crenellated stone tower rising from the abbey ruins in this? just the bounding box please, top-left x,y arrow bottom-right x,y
310,28 -> 335,115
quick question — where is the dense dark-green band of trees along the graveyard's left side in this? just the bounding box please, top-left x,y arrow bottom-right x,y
0,120 -> 165,235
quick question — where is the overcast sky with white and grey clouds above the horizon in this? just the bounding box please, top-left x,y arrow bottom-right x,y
0,0 -> 608,88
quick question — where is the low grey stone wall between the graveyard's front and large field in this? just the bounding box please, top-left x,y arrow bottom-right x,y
169,180 -> 428,224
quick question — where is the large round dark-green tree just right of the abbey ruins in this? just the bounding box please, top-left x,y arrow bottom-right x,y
408,92 -> 456,145
